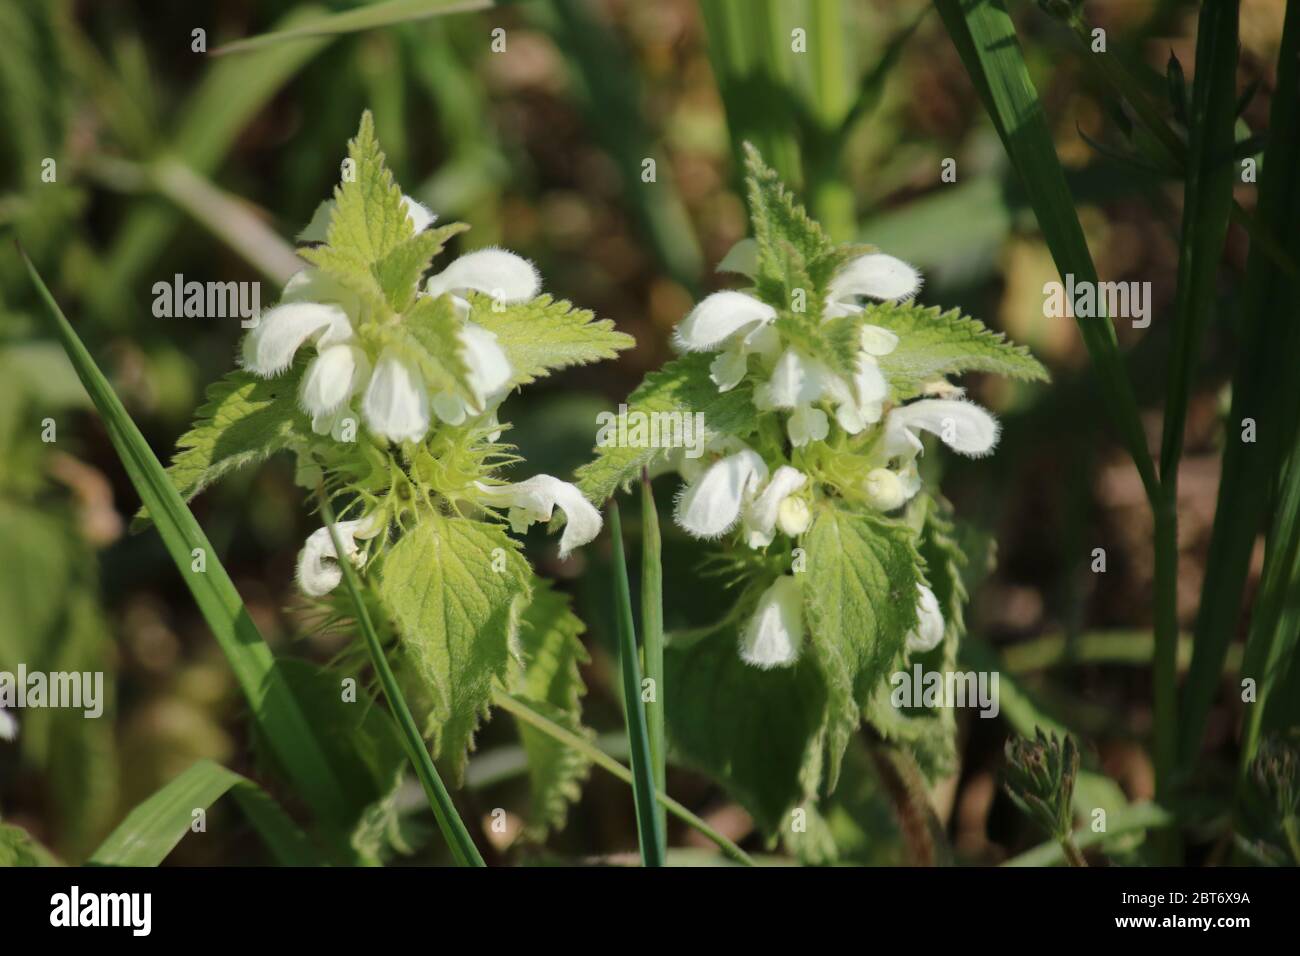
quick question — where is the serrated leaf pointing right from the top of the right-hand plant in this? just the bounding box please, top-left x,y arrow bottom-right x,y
866,303 -> 1049,401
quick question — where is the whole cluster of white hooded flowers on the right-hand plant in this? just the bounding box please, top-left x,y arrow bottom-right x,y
659,248 -> 998,667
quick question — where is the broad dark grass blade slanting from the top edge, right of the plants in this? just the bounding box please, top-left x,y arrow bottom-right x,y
935,0 -> 1157,501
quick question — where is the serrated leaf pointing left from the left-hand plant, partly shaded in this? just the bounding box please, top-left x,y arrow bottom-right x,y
137,362 -> 311,523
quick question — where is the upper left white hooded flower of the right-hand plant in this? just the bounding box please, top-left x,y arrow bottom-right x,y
673,291 -> 779,392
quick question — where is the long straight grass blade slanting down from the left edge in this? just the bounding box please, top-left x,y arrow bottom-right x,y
18,247 -> 361,842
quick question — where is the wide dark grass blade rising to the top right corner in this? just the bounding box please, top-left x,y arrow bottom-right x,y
1179,3 -> 1300,767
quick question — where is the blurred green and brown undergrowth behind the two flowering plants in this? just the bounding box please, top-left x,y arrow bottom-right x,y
0,0 -> 1283,864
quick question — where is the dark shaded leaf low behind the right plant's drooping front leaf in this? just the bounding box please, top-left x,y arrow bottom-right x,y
663,628 -> 827,834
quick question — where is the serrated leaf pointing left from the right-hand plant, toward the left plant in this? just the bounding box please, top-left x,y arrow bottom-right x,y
577,352 -> 758,503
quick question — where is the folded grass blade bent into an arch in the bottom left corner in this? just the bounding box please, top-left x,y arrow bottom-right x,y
90,760 -> 324,866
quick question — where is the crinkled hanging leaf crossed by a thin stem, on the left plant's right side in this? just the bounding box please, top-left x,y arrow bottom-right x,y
511,580 -> 595,840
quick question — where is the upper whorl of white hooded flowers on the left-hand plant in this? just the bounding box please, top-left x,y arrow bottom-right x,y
243,208 -> 540,441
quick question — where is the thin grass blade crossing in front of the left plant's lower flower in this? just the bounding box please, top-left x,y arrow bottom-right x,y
316,489 -> 484,866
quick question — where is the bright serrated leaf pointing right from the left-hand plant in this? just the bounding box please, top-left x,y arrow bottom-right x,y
471,294 -> 636,386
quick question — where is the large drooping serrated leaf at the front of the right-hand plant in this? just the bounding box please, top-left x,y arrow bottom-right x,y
800,506 -> 923,790
